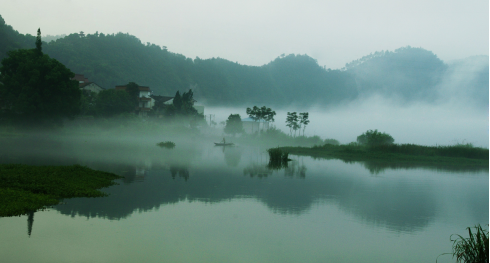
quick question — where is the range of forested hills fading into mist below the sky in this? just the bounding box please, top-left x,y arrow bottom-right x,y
0,13 -> 489,106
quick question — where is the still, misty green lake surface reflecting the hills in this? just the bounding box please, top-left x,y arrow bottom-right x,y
0,138 -> 489,262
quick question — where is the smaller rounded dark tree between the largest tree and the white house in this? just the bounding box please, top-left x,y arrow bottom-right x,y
95,89 -> 135,117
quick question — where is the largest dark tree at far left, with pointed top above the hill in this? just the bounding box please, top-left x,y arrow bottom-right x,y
0,31 -> 81,125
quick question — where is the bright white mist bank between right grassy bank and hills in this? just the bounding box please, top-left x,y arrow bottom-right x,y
205,96 -> 489,148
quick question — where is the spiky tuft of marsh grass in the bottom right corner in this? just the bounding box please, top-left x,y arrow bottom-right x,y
436,225 -> 490,263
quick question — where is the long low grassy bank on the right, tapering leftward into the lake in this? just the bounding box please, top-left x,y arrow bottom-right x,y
281,144 -> 489,170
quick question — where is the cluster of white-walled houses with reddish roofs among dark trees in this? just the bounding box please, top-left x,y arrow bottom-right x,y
72,74 -> 204,115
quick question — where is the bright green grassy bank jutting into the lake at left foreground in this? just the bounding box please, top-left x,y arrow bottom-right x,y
0,164 -> 120,217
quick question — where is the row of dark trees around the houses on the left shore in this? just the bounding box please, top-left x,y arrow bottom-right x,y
0,29 -> 203,126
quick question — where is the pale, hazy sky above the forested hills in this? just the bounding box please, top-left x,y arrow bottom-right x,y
0,0 -> 489,69
